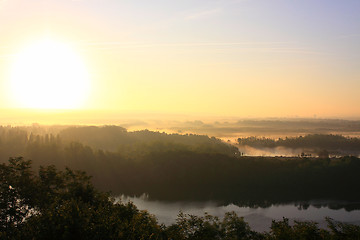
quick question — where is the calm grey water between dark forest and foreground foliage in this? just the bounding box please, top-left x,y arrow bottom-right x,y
118,196 -> 360,232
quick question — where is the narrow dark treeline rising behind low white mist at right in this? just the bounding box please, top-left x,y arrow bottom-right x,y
238,134 -> 360,152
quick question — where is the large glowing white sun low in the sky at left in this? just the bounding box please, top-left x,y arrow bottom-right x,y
10,39 -> 90,109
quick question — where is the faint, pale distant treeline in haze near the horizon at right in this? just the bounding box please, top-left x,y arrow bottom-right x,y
169,118 -> 360,136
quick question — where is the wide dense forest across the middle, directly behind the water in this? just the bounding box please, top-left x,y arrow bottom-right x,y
0,126 -> 360,210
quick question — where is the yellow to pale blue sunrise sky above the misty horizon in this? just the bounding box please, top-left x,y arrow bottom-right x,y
0,0 -> 360,119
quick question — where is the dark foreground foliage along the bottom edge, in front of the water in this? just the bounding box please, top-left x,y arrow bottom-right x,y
0,158 -> 360,240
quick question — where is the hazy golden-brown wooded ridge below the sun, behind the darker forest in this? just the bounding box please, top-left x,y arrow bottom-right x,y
0,126 -> 239,159
